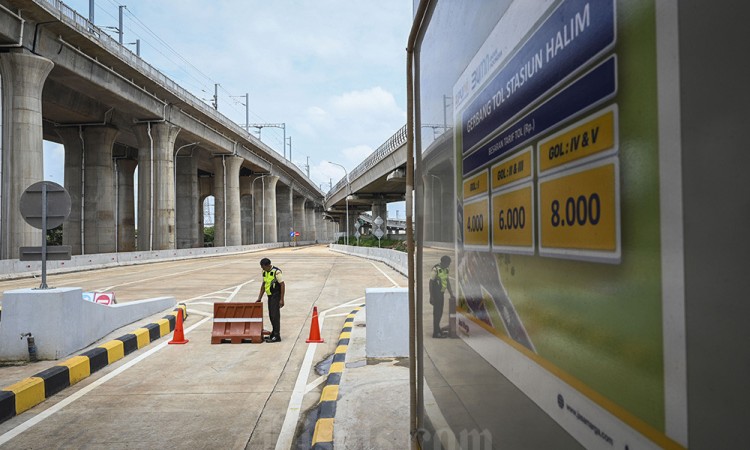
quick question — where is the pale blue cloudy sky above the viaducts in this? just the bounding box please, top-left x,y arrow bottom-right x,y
45,0 -> 412,218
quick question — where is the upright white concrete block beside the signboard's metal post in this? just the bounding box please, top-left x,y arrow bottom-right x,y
365,288 -> 409,358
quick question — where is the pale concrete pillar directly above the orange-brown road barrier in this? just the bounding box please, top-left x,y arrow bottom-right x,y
213,155 -> 243,247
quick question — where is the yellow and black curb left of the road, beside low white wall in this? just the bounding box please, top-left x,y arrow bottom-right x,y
0,303 -> 187,423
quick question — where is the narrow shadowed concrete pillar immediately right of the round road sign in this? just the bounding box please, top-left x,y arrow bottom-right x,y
55,127 -> 84,255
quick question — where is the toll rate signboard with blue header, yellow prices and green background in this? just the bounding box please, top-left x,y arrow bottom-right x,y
452,0 -> 686,448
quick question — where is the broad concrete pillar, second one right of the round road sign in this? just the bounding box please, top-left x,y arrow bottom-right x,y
83,126 -> 119,254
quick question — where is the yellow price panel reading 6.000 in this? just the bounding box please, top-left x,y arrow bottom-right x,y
492,182 -> 534,255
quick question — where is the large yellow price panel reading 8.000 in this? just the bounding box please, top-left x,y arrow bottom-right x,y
538,157 -> 621,263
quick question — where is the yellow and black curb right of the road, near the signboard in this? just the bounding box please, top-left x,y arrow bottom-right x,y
312,305 -> 365,450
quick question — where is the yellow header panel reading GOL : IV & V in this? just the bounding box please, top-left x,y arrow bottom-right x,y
537,105 -> 617,175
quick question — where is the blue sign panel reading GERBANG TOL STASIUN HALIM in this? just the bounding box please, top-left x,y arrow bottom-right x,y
461,0 -> 615,154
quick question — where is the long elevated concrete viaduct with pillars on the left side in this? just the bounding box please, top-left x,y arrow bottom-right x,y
0,0 -> 328,259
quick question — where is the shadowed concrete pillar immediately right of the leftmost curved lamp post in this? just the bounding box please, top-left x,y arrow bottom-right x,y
175,155 -> 203,248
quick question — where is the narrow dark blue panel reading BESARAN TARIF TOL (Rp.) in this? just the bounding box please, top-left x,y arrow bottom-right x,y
463,55 -> 617,176
